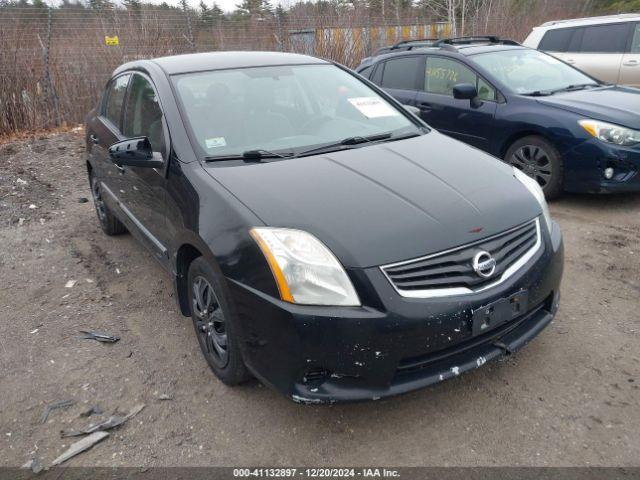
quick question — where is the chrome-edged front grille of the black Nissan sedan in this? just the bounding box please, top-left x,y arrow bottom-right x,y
382,219 -> 542,297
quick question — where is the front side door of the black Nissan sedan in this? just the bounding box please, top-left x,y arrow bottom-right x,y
119,72 -> 169,267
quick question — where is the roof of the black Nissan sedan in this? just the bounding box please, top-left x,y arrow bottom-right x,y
135,52 -> 329,75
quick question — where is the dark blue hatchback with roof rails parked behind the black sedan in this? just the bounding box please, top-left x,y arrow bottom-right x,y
357,37 -> 640,198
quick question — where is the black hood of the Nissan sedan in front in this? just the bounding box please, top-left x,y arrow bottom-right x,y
206,131 -> 541,268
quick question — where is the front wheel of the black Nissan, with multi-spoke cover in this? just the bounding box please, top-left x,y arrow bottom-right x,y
188,257 -> 251,385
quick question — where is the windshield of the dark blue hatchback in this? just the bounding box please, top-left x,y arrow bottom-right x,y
473,49 -> 597,94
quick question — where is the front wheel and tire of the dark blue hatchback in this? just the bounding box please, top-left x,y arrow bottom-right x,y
504,135 -> 564,200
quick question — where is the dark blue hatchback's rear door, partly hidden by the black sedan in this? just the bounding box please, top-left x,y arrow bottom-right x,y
374,55 -> 424,105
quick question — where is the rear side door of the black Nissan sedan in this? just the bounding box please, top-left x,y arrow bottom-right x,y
87,73 -> 131,209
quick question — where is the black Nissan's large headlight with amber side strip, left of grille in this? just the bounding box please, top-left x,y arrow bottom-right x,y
251,227 -> 360,306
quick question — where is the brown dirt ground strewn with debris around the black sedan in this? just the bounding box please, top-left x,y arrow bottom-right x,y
0,133 -> 640,467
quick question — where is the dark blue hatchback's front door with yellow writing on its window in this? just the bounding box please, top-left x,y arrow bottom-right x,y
415,56 -> 498,151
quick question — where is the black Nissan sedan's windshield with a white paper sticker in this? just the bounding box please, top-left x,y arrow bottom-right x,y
173,65 -> 421,157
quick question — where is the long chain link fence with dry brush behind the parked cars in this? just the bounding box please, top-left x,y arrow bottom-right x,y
0,0 -> 596,136
